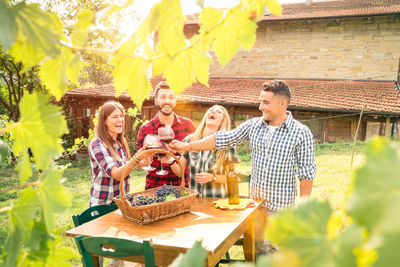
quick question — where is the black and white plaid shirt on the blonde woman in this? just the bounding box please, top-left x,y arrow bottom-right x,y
182,138 -> 238,198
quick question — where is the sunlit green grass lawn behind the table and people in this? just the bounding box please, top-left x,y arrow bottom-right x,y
0,143 -> 365,266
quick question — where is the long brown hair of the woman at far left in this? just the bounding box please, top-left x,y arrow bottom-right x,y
96,101 -> 131,161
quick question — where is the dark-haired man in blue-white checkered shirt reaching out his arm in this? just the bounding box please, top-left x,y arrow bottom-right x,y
170,80 -> 316,212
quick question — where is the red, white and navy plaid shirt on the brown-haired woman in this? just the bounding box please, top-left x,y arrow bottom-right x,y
88,137 -> 129,206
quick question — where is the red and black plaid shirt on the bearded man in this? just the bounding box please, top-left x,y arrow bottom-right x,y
136,114 -> 195,189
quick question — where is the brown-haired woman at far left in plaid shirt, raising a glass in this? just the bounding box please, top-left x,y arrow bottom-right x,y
88,101 -> 152,206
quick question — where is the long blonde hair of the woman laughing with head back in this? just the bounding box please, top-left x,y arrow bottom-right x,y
188,105 -> 231,173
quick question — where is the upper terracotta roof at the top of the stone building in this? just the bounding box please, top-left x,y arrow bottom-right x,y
187,0 -> 400,24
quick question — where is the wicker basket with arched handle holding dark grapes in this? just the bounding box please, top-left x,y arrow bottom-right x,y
113,149 -> 197,224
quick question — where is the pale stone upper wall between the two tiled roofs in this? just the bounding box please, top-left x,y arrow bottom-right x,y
208,15 -> 400,80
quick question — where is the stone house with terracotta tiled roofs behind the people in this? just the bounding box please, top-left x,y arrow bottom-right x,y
65,0 -> 400,142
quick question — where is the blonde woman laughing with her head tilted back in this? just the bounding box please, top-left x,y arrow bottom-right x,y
166,105 -> 237,197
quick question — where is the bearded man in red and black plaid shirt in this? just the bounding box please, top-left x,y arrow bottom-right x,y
136,82 -> 195,189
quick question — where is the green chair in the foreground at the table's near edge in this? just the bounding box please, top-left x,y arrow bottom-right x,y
75,236 -> 155,267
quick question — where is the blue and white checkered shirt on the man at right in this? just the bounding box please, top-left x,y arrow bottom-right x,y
215,112 -> 316,211
